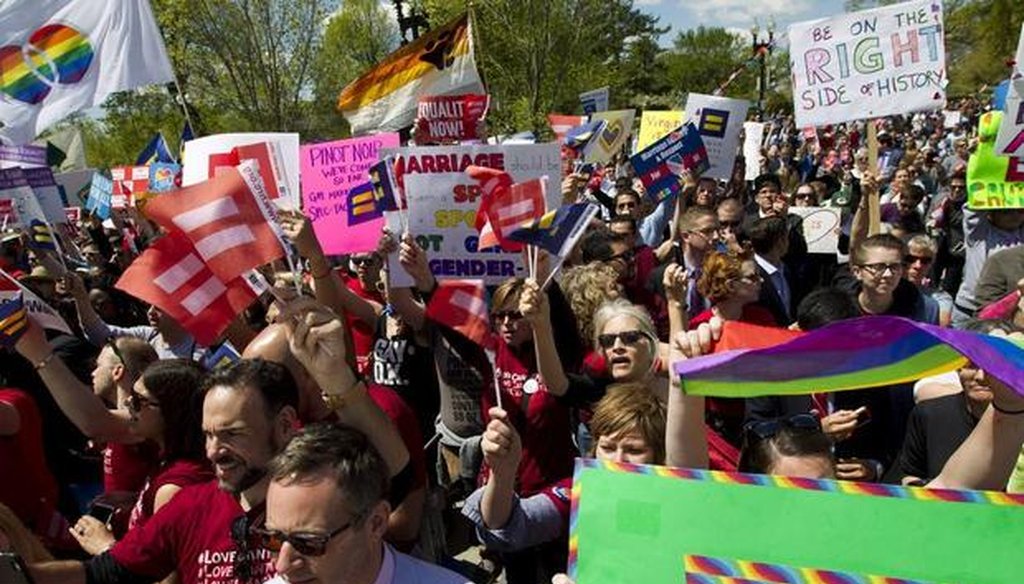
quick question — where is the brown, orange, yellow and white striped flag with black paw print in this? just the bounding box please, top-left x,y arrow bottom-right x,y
338,14 -> 485,135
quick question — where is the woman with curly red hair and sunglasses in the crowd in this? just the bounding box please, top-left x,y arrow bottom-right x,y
690,251 -> 778,327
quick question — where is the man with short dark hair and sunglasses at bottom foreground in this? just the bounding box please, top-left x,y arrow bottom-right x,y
260,424 -> 468,584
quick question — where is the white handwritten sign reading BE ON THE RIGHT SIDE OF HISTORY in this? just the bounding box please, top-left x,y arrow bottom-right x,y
790,0 -> 948,128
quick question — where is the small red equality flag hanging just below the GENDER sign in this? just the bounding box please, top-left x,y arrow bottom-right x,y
426,280 -> 492,348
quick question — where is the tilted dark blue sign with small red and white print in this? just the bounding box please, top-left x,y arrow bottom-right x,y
630,122 -> 710,201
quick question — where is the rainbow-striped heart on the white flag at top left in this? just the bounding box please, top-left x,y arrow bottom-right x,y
0,25 -> 94,105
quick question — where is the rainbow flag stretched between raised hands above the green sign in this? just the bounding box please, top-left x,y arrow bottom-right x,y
675,317 -> 1024,398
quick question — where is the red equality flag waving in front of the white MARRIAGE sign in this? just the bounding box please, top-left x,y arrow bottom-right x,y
466,166 -> 547,251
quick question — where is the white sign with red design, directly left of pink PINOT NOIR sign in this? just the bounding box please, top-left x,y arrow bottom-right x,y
181,132 -> 300,209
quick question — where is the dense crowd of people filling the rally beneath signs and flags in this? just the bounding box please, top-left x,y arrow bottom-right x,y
0,100 -> 1024,584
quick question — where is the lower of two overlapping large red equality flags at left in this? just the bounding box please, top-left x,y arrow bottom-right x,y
115,232 -> 266,345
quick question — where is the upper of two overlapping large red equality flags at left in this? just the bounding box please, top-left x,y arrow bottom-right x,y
145,161 -> 285,282
